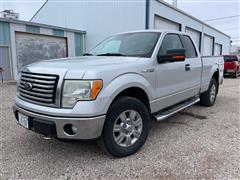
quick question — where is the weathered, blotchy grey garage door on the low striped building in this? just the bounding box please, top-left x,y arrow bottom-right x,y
16,32 -> 67,71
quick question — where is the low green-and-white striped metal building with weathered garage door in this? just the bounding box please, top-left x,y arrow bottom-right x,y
0,18 -> 85,80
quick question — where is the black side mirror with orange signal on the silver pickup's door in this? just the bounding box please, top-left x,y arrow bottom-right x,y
157,49 -> 186,64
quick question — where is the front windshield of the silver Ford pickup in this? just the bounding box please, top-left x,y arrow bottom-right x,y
88,32 -> 160,57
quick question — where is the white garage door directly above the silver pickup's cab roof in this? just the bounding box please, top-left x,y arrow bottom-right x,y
154,15 -> 180,31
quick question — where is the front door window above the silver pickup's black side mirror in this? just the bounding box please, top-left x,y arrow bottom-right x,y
158,34 -> 183,55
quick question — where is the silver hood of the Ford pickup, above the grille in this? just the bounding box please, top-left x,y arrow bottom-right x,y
24,56 -> 140,79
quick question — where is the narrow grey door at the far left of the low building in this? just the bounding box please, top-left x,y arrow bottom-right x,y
0,46 -> 11,81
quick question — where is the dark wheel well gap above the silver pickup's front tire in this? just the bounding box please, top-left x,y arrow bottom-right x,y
114,87 -> 150,110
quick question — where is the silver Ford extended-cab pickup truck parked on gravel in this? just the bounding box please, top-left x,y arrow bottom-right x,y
13,30 -> 224,157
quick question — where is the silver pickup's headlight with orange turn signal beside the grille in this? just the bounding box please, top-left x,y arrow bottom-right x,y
62,80 -> 102,107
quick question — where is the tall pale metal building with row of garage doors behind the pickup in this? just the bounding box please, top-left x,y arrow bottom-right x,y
31,0 -> 230,56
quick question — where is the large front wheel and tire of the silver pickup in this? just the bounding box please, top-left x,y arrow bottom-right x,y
98,96 -> 150,157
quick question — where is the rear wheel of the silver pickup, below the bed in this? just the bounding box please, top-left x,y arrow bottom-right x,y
200,79 -> 219,107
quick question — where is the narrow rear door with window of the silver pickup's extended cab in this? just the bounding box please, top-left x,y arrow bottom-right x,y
180,35 -> 202,95
